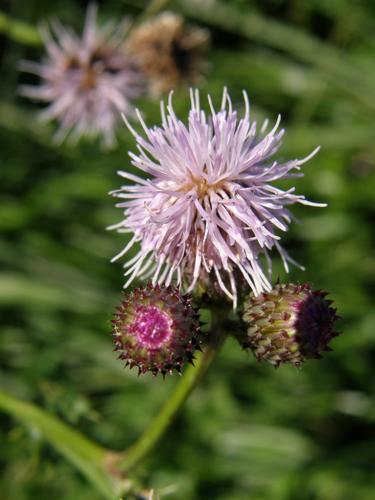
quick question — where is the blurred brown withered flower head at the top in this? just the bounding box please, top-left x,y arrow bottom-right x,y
126,12 -> 209,96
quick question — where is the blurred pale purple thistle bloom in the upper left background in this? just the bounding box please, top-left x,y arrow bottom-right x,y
21,4 -> 142,147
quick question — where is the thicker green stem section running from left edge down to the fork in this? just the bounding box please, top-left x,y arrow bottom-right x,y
0,392 -> 122,500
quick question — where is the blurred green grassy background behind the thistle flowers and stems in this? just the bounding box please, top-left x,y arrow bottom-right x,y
0,0 -> 375,500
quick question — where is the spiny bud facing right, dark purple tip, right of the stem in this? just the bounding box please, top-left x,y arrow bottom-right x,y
239,283 -> 338,367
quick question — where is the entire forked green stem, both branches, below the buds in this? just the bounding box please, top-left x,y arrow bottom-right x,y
0,309 -> 227,494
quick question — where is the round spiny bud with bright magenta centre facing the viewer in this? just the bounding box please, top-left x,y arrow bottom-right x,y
112,284 -> 200,376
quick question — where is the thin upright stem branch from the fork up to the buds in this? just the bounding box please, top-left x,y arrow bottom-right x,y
116,322 -> 226,471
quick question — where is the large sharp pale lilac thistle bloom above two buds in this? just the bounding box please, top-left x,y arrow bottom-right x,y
110,89 -> 324,308
